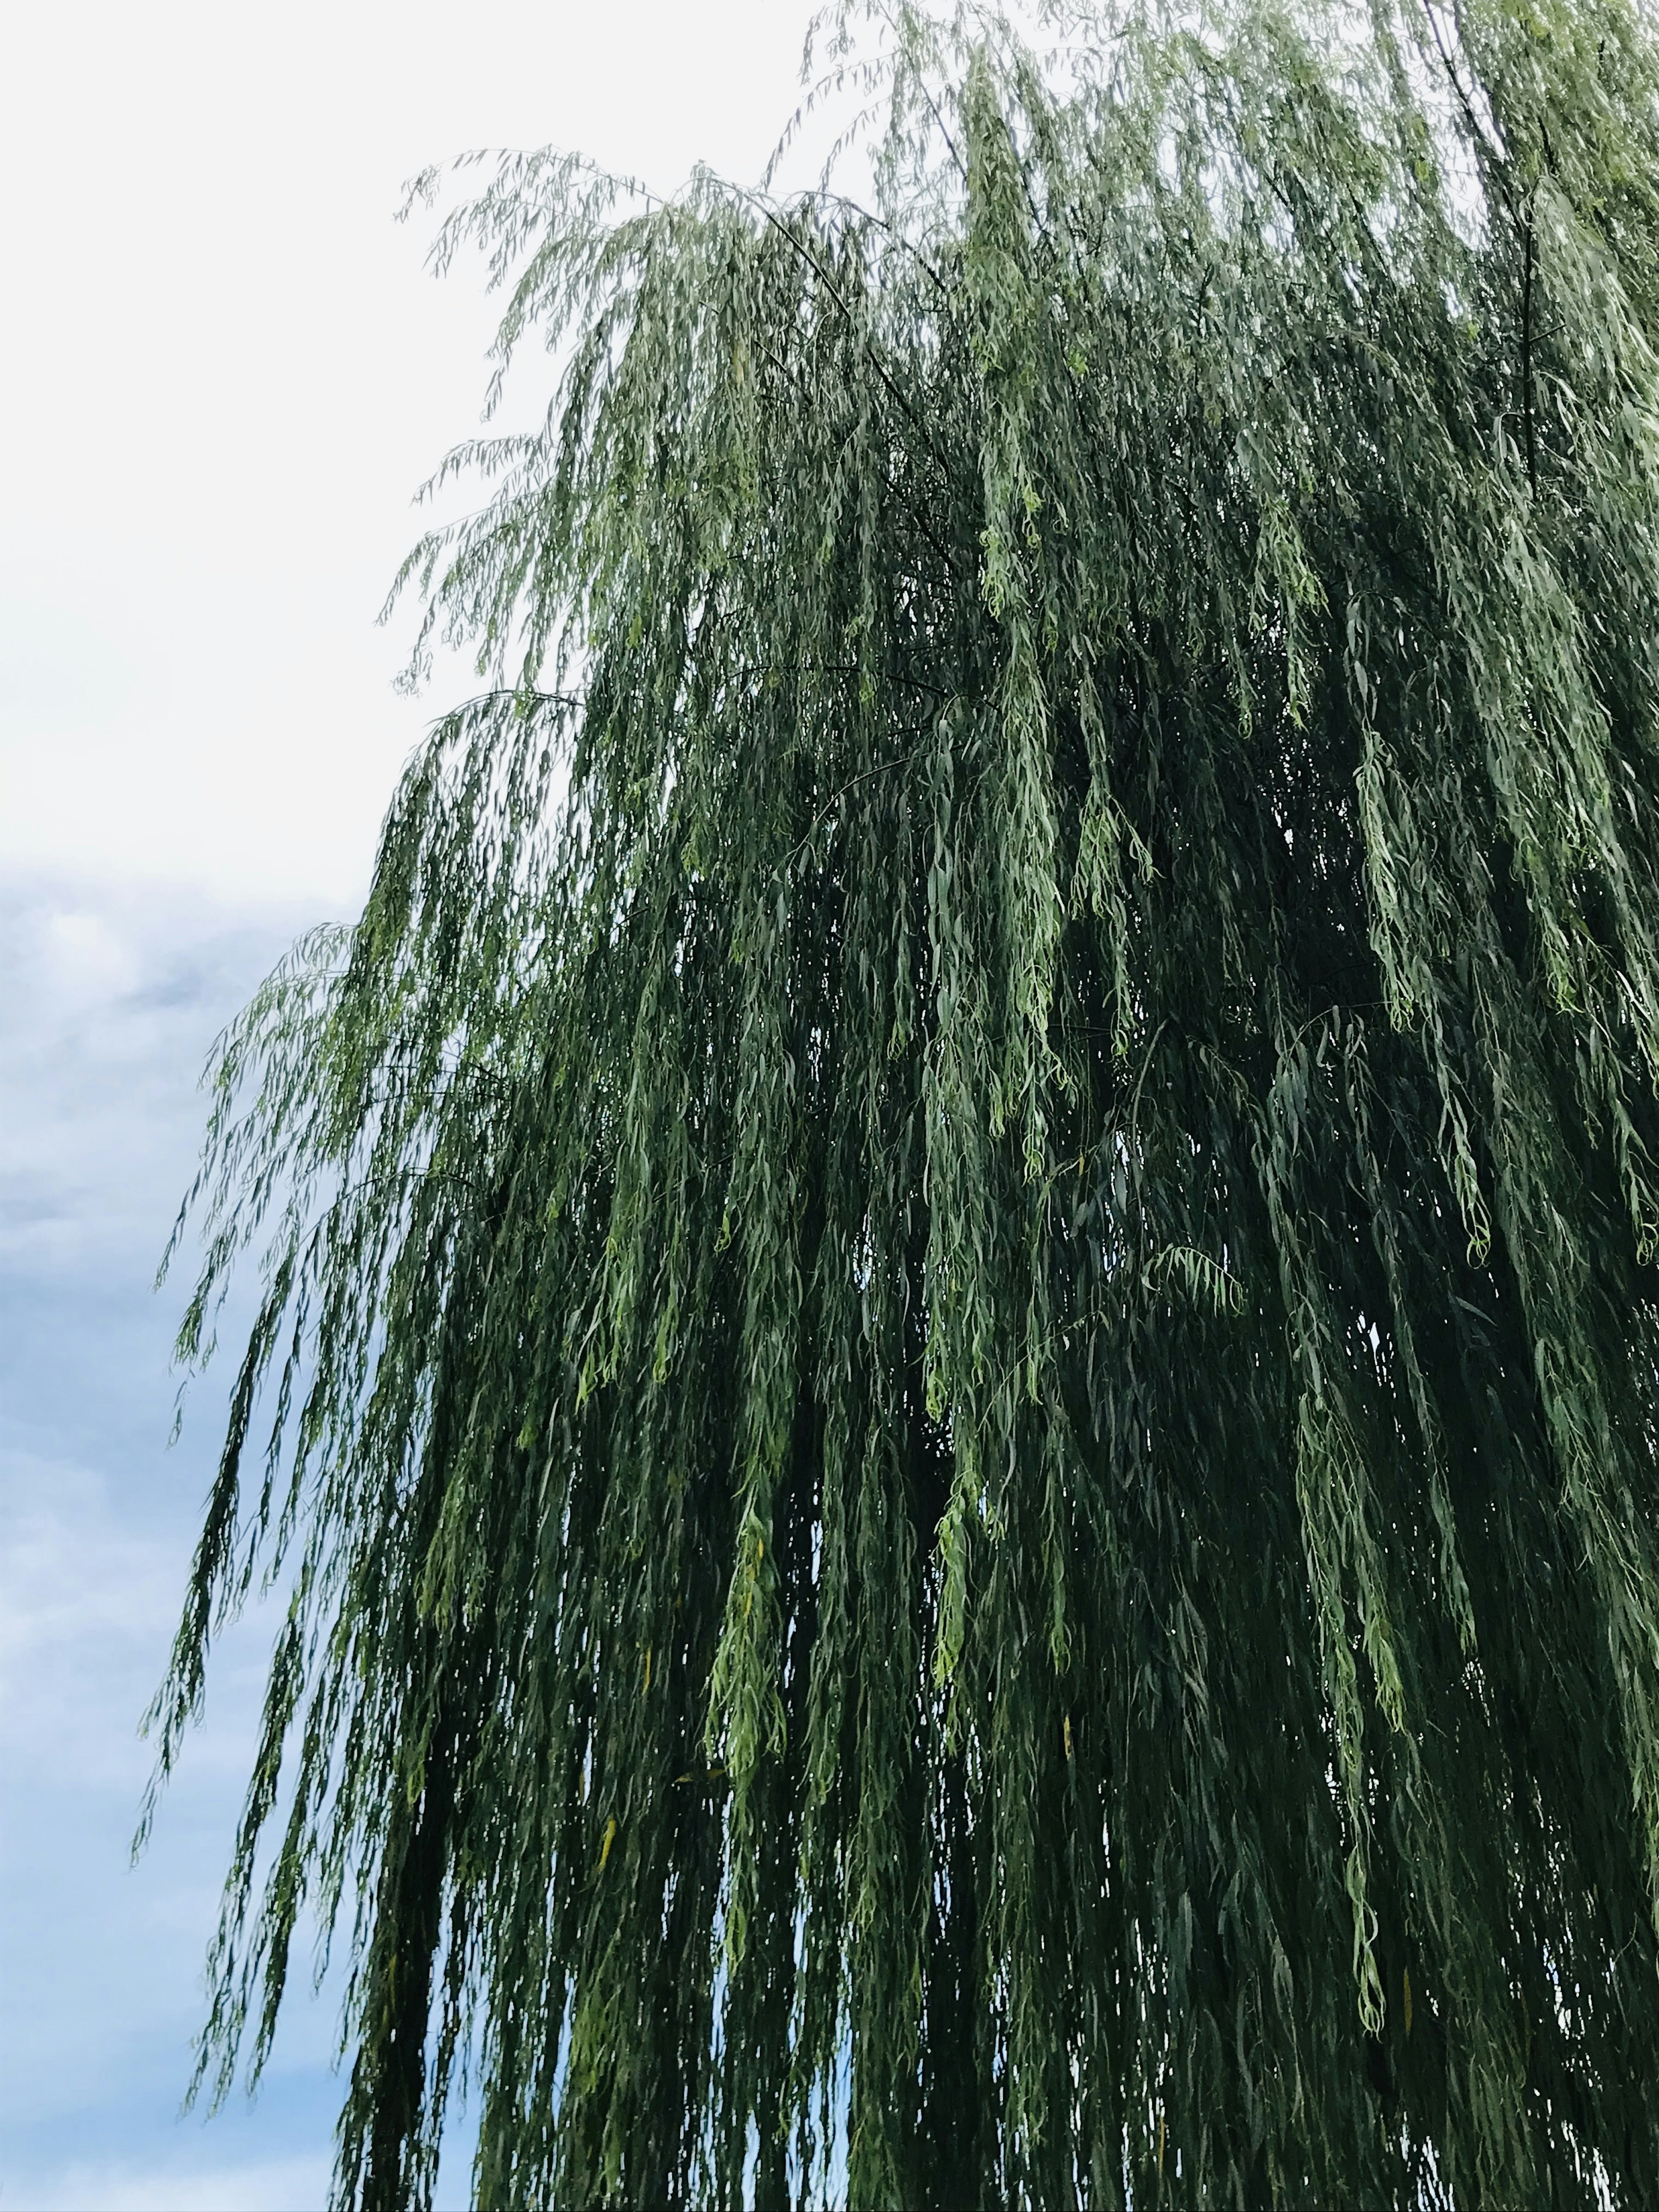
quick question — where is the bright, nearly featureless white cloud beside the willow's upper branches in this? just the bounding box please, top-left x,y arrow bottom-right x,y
0,0 -> 827,905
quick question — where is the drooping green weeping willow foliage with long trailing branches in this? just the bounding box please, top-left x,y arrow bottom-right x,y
153,0 -> 1659,2212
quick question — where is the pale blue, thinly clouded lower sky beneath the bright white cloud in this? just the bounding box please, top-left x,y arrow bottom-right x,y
0,880 -> 338,2212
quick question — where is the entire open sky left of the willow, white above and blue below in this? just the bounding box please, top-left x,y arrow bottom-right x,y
0,0 -> 827,2212
